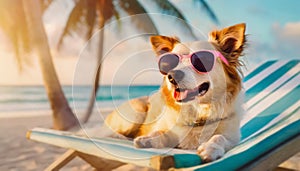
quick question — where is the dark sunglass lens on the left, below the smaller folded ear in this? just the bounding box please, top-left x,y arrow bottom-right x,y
158,54 -> 179,75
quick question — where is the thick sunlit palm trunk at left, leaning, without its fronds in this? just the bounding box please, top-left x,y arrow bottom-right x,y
23,0 -> 78,130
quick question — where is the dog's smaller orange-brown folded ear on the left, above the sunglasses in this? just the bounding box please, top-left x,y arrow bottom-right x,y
150,36 -> 179,55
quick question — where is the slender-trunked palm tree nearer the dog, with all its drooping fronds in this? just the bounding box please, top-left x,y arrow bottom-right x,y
58,0 -> 218,122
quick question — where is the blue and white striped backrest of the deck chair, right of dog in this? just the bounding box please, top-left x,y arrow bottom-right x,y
241,60 -> 300,138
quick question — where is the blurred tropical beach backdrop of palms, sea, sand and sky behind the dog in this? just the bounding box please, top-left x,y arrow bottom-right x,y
0,0 -> 300,170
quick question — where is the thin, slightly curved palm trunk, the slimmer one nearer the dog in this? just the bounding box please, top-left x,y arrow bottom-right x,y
83,17 -> 105,123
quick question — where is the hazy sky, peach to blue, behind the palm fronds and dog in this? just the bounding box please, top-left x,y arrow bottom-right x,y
0,0 -> 300,85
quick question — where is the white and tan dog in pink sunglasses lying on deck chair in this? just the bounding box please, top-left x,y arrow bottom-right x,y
105,23 -> 246,162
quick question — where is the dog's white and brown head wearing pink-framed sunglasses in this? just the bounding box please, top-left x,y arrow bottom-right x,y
150,24 -> 246,105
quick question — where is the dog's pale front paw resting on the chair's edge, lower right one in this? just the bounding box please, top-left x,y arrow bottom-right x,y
197,142 -> 225,162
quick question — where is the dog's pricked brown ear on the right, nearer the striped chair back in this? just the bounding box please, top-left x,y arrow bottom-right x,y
209,23 -> 246,53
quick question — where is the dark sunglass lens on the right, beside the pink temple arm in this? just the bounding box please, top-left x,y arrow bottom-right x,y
191,52 -> 215,72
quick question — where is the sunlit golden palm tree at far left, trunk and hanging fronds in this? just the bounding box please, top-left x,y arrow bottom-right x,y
0,0 -> 78,130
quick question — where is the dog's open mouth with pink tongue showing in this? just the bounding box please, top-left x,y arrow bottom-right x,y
173,82 -> 209,103
